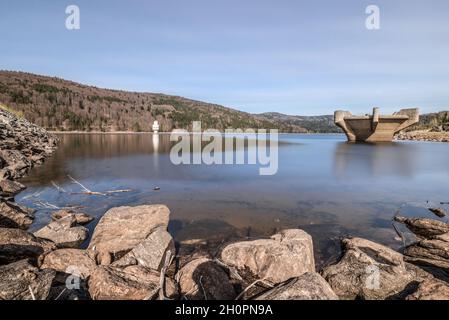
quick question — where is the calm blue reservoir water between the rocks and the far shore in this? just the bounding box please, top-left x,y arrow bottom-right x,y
17,134 -> 449,264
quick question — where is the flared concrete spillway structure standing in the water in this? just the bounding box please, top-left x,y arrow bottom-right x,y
334,108 -> 419,142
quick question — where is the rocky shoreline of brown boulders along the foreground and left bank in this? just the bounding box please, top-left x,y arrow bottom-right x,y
0,110 -> 449,300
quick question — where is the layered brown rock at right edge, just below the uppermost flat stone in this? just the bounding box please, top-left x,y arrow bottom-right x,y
404,233 -> 449,270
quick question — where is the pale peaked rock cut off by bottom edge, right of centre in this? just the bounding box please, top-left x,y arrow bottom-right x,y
256,272 -> 338,300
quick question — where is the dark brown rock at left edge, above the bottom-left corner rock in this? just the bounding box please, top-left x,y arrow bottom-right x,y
0,228 -> 56,264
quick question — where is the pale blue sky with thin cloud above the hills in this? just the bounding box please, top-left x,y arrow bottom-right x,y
0,0 -> 449,115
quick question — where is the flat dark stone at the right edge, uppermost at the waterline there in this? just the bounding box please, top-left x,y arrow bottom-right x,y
394,216 -> 449,238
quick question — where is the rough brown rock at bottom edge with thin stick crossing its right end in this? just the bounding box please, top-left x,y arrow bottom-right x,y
88,266 -> 176,300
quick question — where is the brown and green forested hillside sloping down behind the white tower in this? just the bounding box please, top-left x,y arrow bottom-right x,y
0,71 -> 307,132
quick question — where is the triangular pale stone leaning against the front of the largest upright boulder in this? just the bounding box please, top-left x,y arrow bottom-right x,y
113,226 -> 176,271
